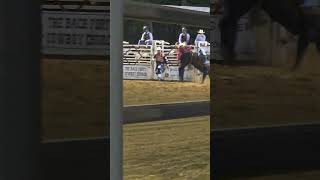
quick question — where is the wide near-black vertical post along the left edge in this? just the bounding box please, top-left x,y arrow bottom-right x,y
0,0 -> 41,180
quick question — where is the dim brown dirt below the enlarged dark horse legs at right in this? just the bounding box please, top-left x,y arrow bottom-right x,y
211,47 -> 320,128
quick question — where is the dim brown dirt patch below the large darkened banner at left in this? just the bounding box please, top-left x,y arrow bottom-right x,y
42,60 -> 109,139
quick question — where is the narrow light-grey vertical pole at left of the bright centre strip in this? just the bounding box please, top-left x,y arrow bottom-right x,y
110,0 -> 123,180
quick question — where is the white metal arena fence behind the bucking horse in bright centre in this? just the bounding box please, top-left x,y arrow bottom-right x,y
123,40 -> 210,81
